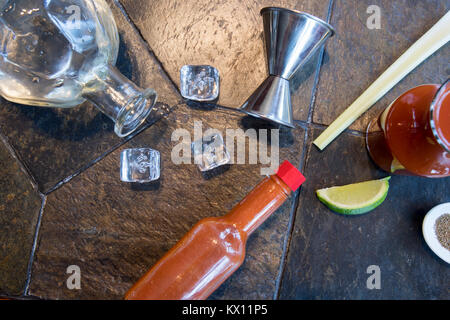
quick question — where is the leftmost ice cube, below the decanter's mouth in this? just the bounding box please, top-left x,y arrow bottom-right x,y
120,148 -> 161,183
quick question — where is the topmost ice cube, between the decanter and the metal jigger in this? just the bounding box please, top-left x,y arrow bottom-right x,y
180,65 -> 219,101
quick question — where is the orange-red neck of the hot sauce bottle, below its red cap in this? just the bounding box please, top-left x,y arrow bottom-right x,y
223,175 -> 292,236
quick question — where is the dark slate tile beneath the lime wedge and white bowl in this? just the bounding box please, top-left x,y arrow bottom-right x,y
280,130 -> 450,299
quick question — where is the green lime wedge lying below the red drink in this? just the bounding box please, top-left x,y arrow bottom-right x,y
316,177 -> 391,214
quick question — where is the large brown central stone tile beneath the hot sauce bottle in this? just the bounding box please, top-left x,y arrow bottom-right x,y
30,105 -> 304,299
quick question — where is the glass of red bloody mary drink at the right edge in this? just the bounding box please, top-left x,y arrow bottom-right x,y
366,80 -> 450,178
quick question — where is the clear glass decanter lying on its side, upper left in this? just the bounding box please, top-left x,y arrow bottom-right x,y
0,0 -> 156,137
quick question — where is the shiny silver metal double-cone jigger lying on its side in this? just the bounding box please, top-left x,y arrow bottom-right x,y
241,7 -> 334,128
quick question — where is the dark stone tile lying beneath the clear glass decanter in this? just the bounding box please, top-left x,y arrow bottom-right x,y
0,1 -> 180,192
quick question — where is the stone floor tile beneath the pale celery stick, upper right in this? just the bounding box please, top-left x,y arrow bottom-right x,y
313,0 -> 450,130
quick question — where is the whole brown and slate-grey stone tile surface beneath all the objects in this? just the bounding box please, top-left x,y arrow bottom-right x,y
0,0 -> 450,299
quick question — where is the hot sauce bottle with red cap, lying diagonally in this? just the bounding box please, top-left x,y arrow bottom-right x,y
125,161 -> 305,300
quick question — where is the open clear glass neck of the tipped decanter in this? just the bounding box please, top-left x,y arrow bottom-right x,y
82,64 -> 157,137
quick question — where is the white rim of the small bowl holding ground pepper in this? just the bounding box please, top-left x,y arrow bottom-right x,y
422,202 -> 450,263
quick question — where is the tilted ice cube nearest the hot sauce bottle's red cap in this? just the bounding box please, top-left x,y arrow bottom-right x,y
192,133 -> 231,171
